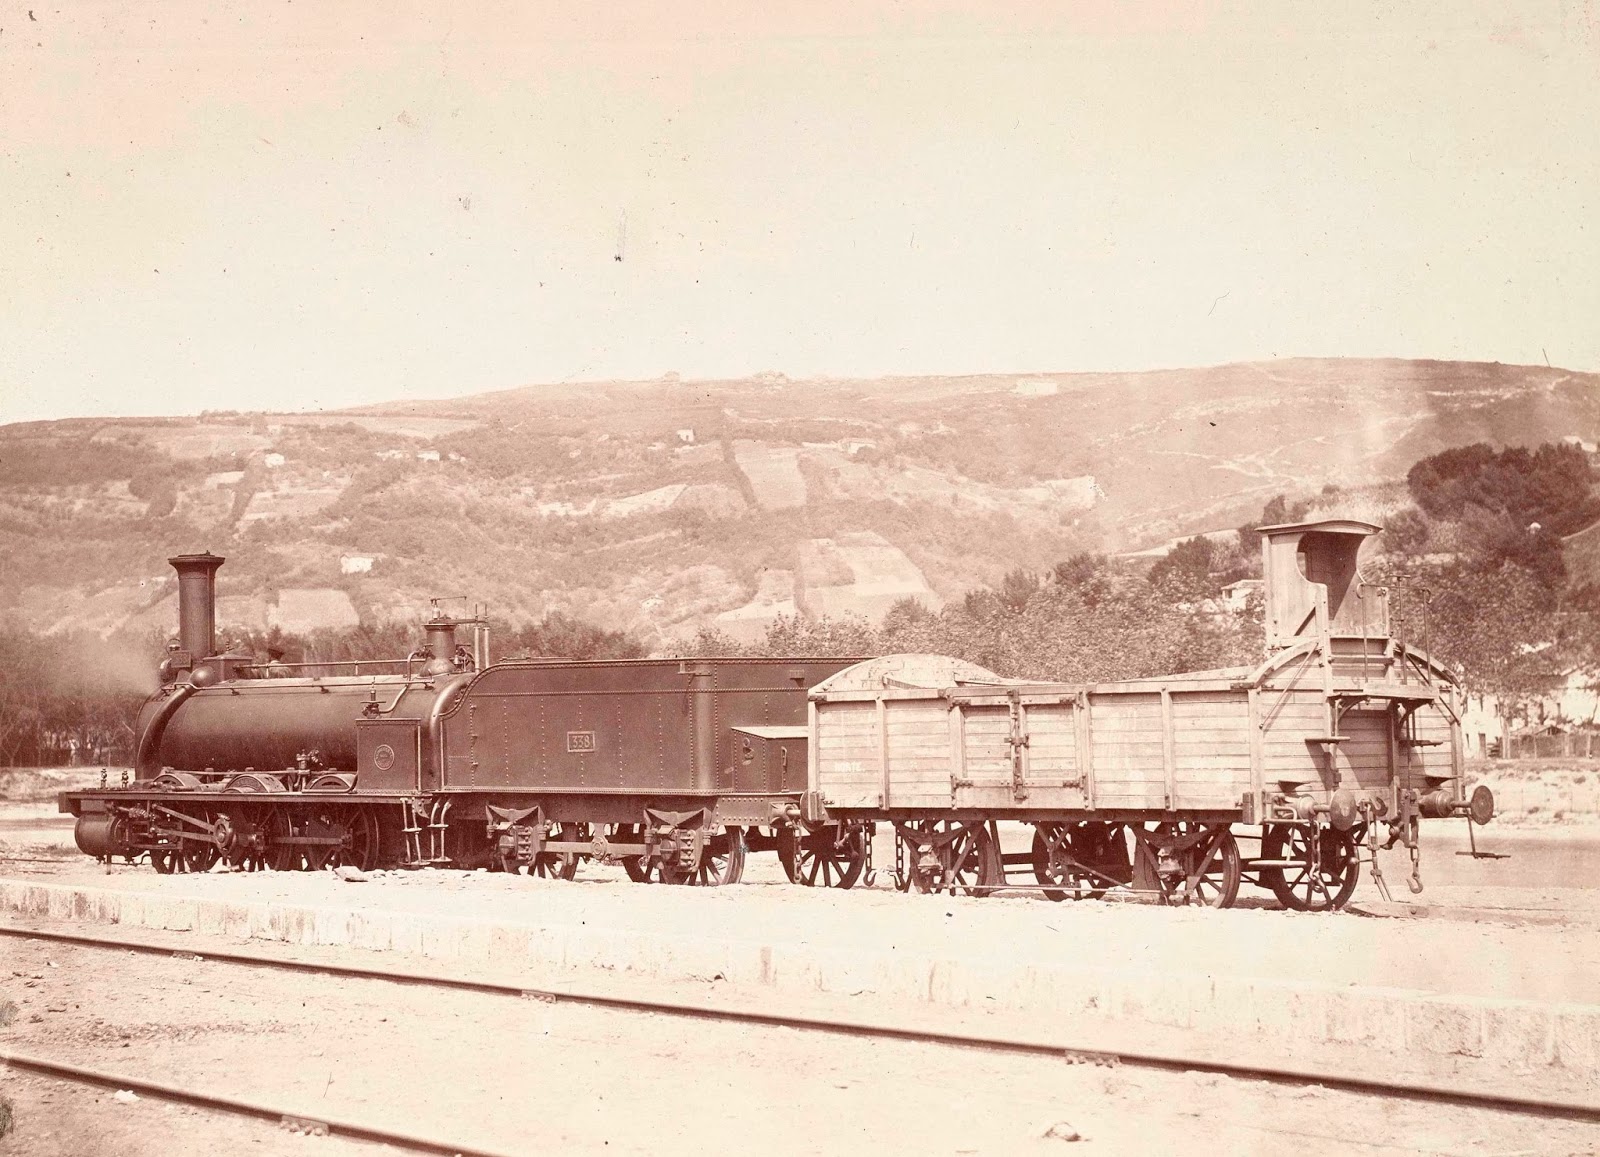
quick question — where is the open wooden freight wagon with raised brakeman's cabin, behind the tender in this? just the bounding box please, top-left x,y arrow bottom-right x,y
803,520 -> 1493,909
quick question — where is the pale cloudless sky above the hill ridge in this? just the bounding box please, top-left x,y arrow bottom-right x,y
0,0 -> 1600,422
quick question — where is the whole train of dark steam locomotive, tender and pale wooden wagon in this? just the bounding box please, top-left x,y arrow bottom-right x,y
59,520 -> 1493,909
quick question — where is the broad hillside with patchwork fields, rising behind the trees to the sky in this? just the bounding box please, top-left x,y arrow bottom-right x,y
0,358 -> 1600,645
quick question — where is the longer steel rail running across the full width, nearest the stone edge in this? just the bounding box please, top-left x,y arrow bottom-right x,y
0,925 -> 1600,1123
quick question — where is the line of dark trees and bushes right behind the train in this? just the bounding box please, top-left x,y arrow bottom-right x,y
0,445 -> 1600,765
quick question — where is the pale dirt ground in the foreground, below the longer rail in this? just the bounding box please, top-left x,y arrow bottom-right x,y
0,936 -> 1600,1157
